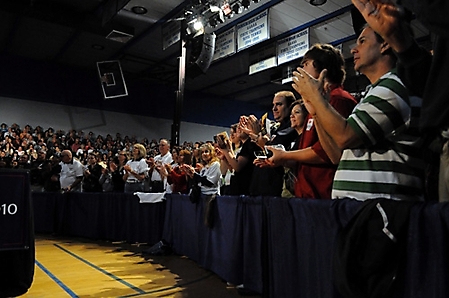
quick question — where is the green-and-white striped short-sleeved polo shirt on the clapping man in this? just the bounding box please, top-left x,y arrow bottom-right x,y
332,71 -> 424,200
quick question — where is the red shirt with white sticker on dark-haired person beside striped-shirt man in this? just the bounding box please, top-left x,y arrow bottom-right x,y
295,87 -> 357,199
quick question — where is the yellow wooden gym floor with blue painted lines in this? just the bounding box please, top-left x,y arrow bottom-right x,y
21,236 -> 258,298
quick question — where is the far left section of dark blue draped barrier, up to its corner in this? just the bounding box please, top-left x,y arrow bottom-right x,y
32,193 -> 165,245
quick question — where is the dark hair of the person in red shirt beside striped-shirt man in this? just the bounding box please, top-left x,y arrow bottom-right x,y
302,44 -> 346,85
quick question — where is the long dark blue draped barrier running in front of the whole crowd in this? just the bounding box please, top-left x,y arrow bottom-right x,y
33,193 -> 449,298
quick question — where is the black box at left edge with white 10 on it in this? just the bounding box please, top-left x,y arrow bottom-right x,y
0,169 -> 35,297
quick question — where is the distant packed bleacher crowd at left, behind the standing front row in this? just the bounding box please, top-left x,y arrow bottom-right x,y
0,123 -> 206,191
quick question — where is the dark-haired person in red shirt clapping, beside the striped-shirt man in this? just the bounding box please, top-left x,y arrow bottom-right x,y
269,44 -> 357,199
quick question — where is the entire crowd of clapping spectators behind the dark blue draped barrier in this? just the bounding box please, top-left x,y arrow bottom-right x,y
0,0 -> 449,201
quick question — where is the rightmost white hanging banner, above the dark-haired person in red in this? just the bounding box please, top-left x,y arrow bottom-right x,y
278,28 -> 309,65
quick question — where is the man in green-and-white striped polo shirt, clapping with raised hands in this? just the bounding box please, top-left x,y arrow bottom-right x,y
293,27 -> 424,201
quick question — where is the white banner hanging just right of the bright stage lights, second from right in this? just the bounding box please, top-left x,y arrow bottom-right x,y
237,10 -> 270,51
